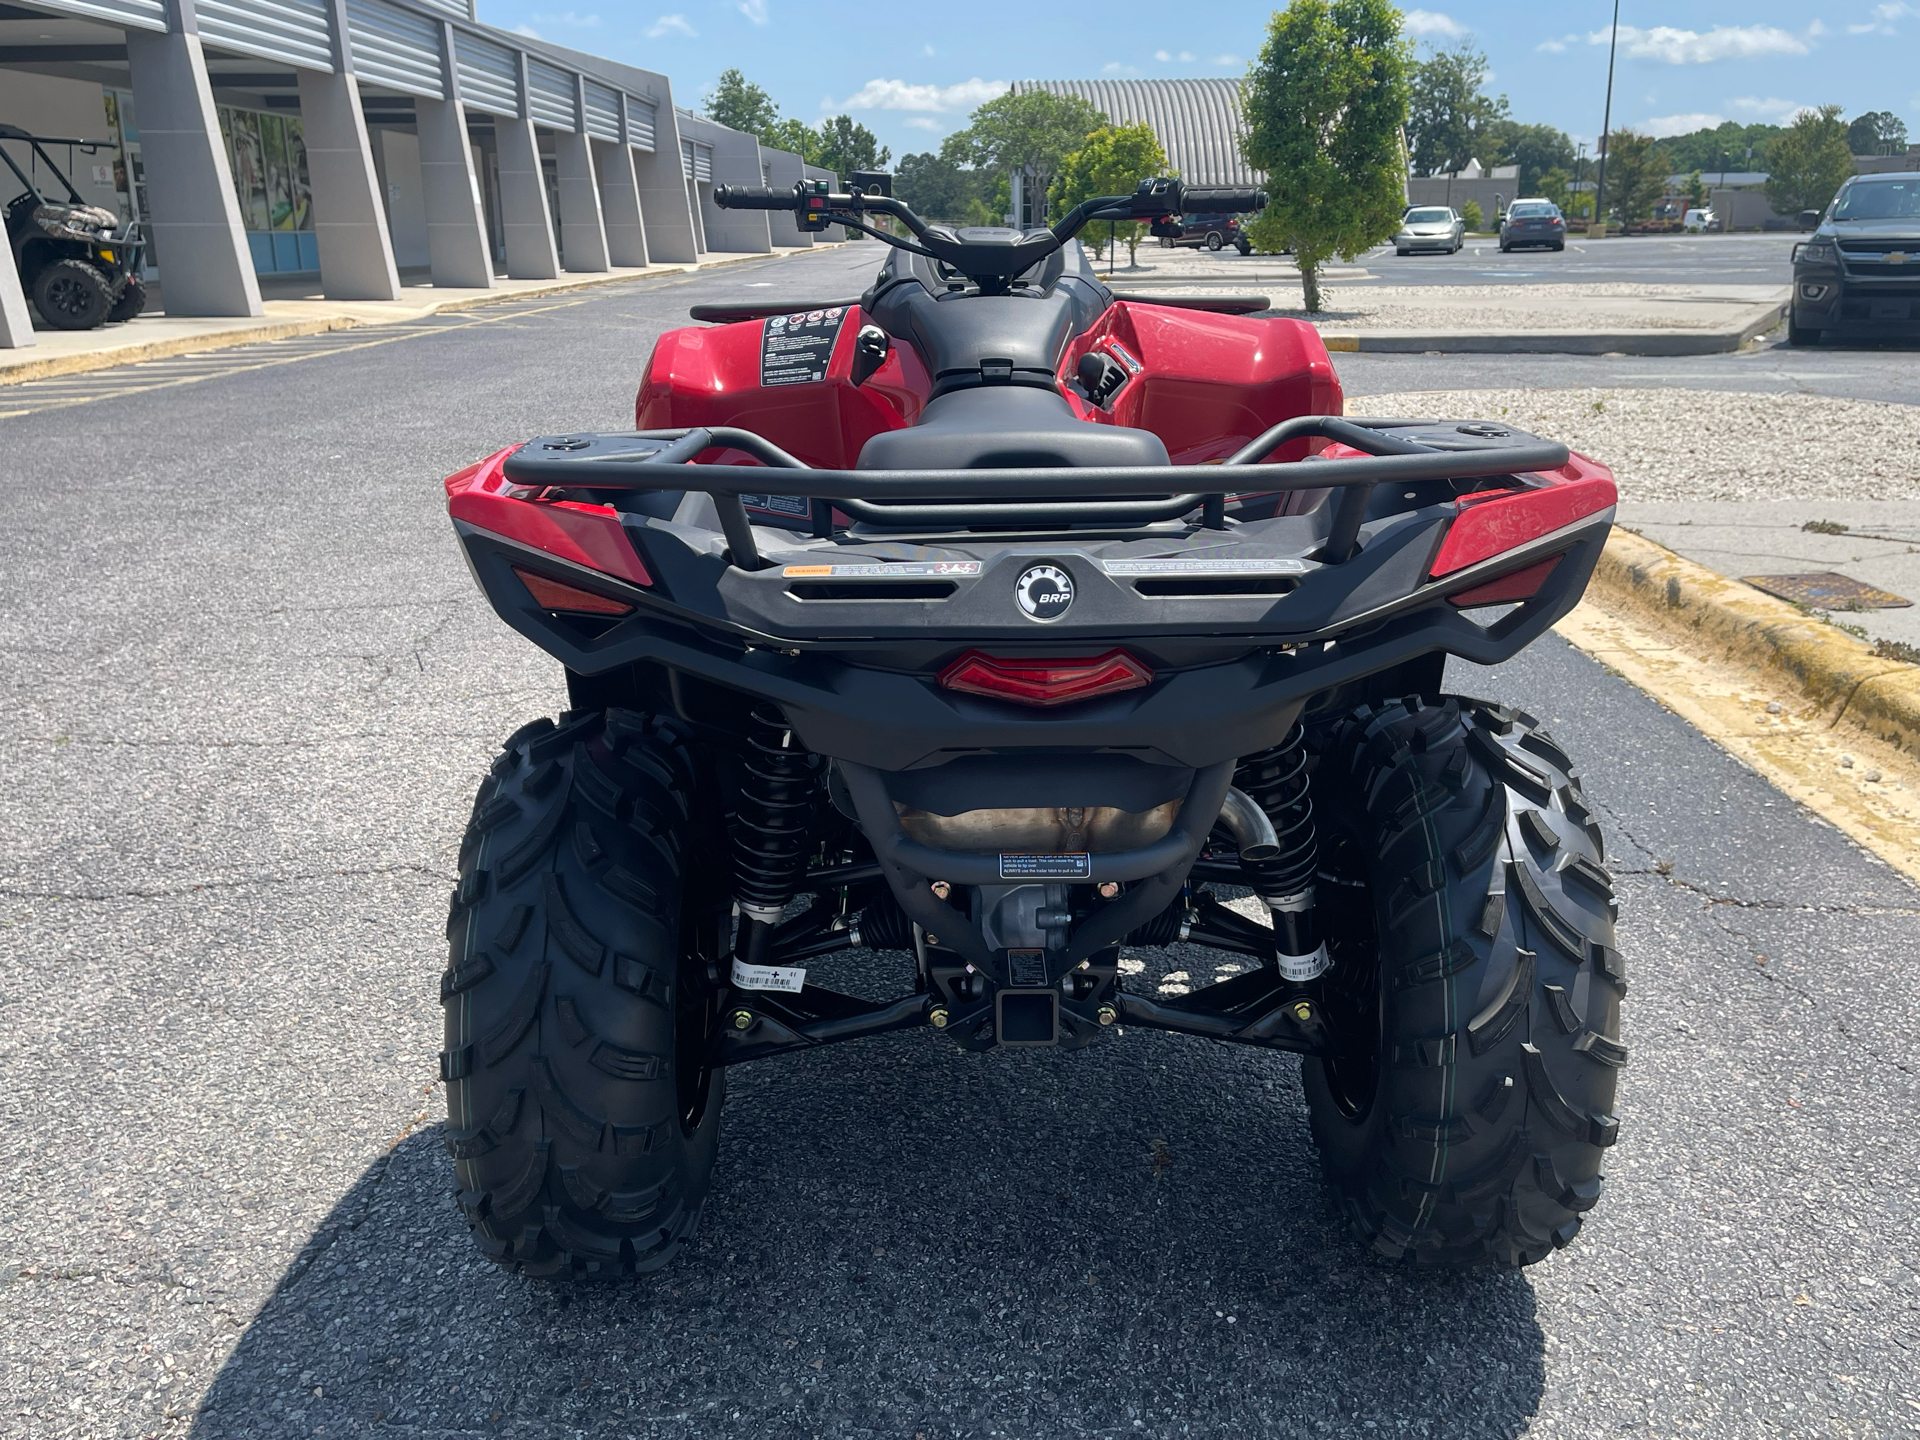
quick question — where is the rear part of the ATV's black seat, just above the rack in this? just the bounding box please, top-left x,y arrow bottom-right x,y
860,384 -> 1171,470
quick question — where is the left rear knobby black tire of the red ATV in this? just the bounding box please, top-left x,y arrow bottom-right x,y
440,710 -> 728,1277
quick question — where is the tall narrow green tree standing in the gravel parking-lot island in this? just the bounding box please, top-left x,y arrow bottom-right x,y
1244,0 -> 1411,315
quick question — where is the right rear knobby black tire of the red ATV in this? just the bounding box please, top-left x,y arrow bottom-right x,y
1304,697 -> 1626,1265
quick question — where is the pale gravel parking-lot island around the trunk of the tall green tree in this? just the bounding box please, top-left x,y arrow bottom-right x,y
1102,246 -> 1788,355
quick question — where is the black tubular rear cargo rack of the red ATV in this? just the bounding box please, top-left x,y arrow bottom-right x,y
505,415 -> 1569,570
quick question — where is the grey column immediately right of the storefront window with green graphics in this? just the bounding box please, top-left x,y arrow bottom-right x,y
297,69 -> 399,300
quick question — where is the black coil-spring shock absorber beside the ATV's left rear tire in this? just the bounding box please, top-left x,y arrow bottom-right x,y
733,705 -> 822,964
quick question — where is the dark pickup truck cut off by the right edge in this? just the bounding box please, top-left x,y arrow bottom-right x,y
1788,171 -> 1920,346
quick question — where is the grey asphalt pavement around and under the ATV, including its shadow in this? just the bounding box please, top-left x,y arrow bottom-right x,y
0,248 -> 1920,1440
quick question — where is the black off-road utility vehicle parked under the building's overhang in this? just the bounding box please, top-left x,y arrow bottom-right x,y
0,125 -> 146,330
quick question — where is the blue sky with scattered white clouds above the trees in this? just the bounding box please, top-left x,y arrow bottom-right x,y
480,0 -> 1920,157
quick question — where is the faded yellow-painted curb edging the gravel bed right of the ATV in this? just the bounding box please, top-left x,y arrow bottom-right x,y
1590,528 -> 1920,755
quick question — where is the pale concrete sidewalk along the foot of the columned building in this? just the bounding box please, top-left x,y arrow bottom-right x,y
0,244 -> 817,386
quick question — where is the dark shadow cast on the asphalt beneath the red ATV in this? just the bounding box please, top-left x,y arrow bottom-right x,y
194,1033 -> 1551,1440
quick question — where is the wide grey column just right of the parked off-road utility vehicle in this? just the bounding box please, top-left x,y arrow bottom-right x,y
127,19 -> 261,315
